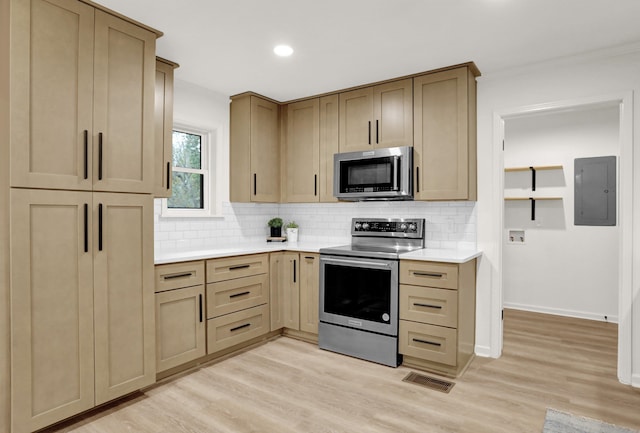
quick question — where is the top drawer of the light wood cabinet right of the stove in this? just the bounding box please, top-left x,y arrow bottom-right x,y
400,260 -> 458,289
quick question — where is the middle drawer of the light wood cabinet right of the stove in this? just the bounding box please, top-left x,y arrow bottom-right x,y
400,284 -> 458,328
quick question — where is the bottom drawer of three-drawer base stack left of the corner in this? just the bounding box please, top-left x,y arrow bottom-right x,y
207,305 -> 270,353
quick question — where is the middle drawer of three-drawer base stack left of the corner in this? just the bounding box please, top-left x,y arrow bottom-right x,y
207,274 -> 269,319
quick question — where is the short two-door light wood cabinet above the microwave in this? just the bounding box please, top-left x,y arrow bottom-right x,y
339,78 -> 413,152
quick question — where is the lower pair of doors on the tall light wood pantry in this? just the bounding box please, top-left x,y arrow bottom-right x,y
11,189 -> 155,433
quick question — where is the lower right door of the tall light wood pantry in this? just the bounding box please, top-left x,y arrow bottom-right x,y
93,193 -> 155,404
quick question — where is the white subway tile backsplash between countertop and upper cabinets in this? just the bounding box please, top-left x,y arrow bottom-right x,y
154,199 -> 476,252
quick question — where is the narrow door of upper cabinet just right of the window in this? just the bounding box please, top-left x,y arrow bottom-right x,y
251,96 -> 280,203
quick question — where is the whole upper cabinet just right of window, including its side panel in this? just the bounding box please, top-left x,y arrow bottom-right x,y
229,94 -> 280,203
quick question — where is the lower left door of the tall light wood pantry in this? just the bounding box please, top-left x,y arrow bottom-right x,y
11,189 -> 94,433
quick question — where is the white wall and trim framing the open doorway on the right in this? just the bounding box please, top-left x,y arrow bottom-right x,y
476,45 -> 640,386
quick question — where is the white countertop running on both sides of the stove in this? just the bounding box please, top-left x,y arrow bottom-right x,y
155,242 -> 482,265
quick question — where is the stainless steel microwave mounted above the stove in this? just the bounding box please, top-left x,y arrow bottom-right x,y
333,146 -> 413,201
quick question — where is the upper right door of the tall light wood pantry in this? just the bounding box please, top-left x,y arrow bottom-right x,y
93,11 -> 156,193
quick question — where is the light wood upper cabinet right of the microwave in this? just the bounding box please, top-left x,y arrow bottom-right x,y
413,64 -> 479,200
